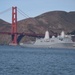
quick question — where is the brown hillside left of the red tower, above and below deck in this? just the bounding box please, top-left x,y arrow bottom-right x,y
0,19 -> 11,44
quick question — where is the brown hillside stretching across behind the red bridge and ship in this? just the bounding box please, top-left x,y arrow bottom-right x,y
0,11 -> 75,43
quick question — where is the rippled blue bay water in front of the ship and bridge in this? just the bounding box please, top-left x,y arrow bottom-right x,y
0,45 -> 75,75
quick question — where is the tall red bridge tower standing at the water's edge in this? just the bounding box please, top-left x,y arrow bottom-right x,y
11,7 -> 17,45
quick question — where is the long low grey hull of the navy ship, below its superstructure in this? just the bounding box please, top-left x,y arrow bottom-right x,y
21,43 -> 75,48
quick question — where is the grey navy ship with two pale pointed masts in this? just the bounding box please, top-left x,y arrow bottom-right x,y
20,31 -> 75,48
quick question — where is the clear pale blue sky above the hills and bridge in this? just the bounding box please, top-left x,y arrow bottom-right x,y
0,0 -> 75,23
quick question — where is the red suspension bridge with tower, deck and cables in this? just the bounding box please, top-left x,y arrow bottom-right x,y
0,7 -> 44,45
